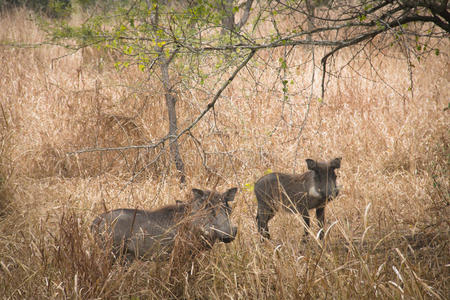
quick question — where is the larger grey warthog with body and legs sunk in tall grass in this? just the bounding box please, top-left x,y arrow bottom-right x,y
91,188 -> 237,261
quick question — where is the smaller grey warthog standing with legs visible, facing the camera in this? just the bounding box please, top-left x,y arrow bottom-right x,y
254,157 -> 341,239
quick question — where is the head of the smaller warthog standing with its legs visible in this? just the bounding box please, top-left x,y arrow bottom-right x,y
306,157 -> 341,199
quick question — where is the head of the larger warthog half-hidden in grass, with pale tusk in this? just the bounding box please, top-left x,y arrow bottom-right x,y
190,188 -> 237,243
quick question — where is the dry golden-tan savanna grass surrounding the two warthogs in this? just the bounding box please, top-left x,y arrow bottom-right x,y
0,10 -> 450,299
